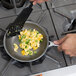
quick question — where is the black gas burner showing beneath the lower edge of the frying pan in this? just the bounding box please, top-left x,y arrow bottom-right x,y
0,47 -> 45,68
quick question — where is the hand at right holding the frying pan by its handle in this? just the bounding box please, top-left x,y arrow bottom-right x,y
54,34 -> 76,57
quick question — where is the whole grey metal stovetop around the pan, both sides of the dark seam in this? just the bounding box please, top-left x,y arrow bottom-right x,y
0,0 -> 76,76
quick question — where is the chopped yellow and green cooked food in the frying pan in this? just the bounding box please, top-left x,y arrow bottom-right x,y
14,29 -> 43,56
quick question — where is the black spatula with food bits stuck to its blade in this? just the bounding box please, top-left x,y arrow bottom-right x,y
6,2 -> 33,36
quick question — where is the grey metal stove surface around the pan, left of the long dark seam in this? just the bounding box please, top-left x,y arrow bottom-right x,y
0,3 -> 66,76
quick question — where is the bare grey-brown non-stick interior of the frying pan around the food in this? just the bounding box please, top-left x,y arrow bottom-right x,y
4,23 -> 48,62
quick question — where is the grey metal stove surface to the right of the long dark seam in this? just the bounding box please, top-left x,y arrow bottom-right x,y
47,0 -> 76,65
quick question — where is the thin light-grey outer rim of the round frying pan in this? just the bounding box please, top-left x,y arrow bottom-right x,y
3,21 -> 49,62
